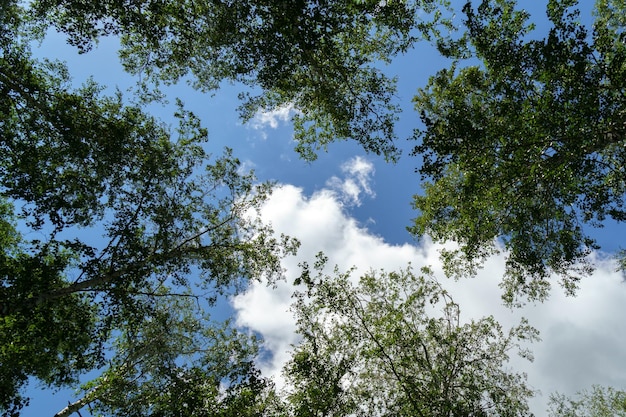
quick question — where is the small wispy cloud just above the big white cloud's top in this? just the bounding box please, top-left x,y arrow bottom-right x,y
326,156 -> 376,206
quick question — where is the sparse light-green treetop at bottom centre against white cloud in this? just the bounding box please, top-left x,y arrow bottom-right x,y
286,262 -> 537,416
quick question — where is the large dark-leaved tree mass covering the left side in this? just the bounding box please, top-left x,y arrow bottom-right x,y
0,1 -> 297,415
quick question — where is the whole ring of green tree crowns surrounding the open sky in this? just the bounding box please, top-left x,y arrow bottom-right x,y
0,0 -> 626,417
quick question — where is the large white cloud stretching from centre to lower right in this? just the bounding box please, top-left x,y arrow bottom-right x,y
233,158 -> 626,415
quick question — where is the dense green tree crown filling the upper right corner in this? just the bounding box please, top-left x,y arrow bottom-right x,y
412,0 -> 626,303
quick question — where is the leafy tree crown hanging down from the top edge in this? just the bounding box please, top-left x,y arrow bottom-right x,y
32,0 -> 446,160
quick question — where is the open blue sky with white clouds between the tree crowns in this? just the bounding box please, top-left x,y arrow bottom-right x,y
23,2 -> 626,417
